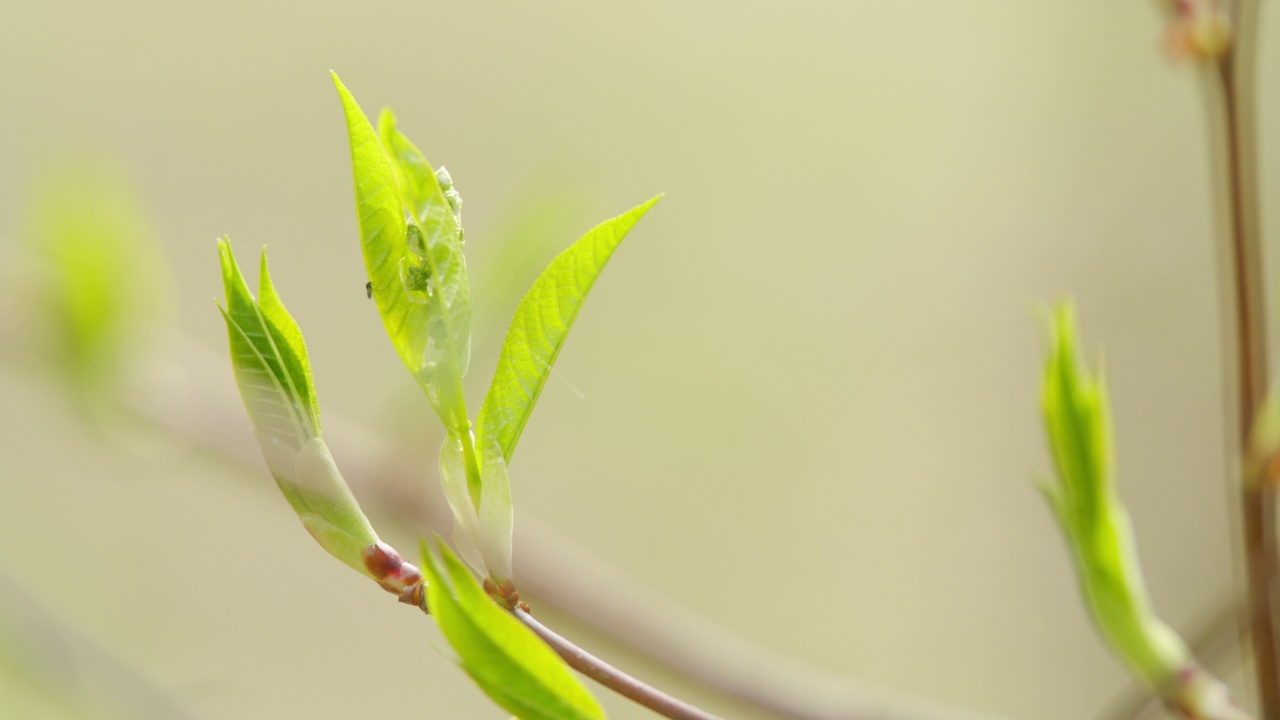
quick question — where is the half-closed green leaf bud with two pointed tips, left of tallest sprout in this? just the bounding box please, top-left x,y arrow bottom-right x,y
218,240 -> 379,577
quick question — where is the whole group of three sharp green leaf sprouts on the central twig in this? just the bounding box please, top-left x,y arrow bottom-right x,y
219,70 -> 658,720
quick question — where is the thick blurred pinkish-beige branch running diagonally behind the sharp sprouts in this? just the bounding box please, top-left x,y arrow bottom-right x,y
123,338 -> 1018,720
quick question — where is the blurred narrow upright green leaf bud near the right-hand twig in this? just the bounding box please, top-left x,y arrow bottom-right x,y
1041,304 -> 1190,687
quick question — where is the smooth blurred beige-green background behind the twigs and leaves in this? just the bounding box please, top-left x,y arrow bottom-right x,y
0,0 -> 1280,720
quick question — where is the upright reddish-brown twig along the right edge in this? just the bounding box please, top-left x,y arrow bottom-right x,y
1213,0 -> 1280,720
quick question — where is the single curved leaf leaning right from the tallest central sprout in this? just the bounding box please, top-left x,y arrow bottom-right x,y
476,195 -> 662,462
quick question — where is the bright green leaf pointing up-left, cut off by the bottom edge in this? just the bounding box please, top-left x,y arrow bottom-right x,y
422,544 -> 604,720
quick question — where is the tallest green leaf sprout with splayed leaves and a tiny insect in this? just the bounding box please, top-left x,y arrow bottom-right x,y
333,76 -> 658,583
